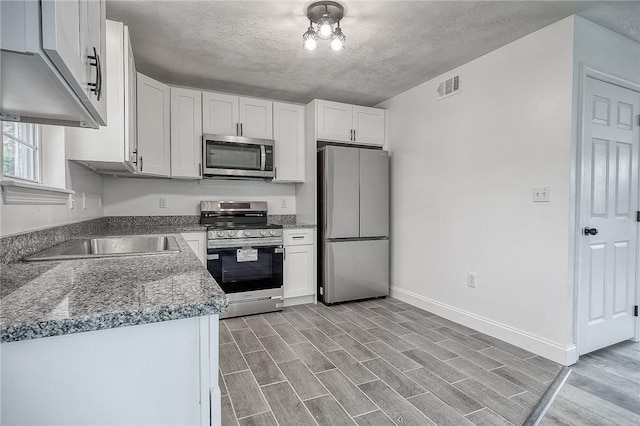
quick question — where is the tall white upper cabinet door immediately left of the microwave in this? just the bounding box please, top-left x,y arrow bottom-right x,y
171,87 -> 202,179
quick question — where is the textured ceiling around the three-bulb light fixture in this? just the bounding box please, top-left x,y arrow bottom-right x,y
107,0 -> 640,105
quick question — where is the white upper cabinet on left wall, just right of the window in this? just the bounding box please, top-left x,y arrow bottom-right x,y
65,21 -> 137,173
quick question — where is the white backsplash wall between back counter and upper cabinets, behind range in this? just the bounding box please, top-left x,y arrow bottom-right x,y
104,177 -> 296,216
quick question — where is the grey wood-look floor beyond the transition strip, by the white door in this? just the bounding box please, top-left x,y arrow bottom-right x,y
540,341 -> 640,426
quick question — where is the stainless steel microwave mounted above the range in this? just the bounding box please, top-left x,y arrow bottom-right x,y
202,134 -> 275,179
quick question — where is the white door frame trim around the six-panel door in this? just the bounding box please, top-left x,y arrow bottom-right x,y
569,64 -> 640,364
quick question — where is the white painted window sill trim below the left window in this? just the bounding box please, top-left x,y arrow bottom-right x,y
0,179 -> 75,205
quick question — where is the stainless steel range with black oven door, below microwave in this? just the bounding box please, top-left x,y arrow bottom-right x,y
200,201 -> 284,318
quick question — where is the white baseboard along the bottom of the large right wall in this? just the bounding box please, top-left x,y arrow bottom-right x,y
391,286 -> 578,365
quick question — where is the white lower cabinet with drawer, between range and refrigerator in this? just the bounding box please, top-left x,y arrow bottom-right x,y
283,229 -> 316,305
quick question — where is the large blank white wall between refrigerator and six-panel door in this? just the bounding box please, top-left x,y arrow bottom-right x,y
380,17 -> 573,362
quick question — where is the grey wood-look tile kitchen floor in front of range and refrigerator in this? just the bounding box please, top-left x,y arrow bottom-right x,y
219,299 -> 561,426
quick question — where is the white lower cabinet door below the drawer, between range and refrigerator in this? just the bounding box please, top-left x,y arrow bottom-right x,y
283,245 -> 315,299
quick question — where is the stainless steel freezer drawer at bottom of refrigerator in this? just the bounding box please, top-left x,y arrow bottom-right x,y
323,239 -> 389,303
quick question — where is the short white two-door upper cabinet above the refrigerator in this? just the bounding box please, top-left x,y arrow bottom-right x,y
316,100 -> 385,146
